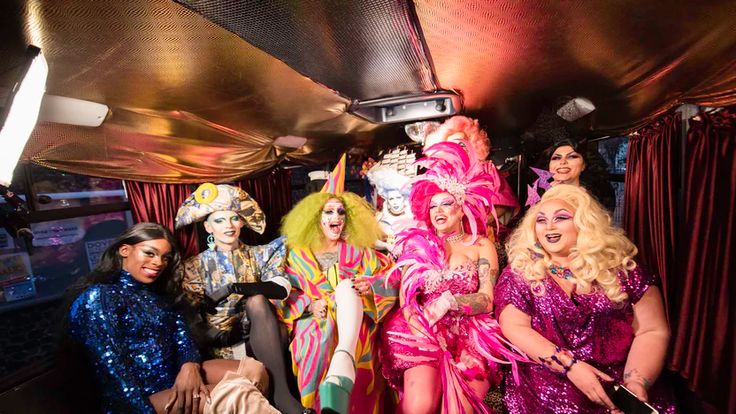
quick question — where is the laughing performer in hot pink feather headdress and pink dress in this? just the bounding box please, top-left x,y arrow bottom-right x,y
381,142 -> 523,414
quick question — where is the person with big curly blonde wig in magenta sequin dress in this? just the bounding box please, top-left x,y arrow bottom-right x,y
495,184 -> 675,414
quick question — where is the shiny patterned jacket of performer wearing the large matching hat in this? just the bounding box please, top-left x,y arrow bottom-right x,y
177,237 -> 291,359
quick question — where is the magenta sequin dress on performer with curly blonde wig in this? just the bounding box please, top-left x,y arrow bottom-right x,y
494,267 -> 676,414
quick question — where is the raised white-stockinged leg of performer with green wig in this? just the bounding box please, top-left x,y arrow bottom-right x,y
325,279 -> 363,383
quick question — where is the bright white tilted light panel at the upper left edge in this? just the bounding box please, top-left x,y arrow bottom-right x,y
0,46 -> 49,186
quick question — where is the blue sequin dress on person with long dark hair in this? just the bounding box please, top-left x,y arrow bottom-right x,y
69,271 -> 200,413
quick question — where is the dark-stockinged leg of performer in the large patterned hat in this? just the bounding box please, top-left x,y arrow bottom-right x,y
245,295 -> 304,414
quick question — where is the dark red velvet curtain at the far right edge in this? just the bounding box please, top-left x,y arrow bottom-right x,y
672,110 -> 736,413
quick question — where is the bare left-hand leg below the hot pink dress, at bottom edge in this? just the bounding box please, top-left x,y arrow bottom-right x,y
401,365 -> 442,414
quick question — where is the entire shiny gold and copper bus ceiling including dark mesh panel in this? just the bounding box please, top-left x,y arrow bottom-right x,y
0,0 -> 736,183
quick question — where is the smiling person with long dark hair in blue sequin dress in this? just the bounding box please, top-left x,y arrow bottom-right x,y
69,223 -> 270,413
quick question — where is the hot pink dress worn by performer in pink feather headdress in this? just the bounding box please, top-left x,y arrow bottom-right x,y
381,261 -> 514,413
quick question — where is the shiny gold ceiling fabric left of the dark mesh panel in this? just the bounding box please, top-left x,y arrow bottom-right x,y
10,0 -> 375,183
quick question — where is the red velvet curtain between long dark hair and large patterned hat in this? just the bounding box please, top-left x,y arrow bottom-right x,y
125,181 -> 199,259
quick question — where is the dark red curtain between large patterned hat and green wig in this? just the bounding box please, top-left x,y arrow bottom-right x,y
236,169 -> 292,245
